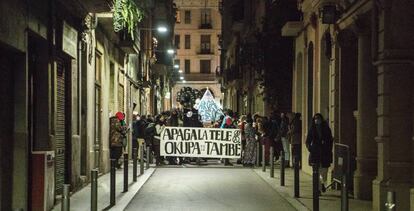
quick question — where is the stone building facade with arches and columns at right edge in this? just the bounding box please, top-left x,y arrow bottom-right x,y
282,0 -> 414,210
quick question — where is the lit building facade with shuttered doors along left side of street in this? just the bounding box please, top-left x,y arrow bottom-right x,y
0,0 -> 175,210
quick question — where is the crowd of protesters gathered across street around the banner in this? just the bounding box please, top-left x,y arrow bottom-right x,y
110,109 -> 333,195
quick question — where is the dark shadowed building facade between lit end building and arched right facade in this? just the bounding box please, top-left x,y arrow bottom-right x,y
218,0 -> 299,116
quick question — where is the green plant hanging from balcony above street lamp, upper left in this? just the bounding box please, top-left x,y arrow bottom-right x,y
112,0 -> 144,40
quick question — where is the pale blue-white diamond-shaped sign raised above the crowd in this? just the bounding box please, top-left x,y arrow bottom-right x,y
196,89 -> 223,122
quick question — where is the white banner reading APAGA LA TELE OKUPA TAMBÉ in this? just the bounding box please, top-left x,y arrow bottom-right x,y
160,127 -> 241,158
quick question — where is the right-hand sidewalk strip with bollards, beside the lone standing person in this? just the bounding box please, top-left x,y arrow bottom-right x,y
254,166 -> 372,211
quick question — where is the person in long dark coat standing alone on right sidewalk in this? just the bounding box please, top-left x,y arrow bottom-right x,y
306,113 -> 333,192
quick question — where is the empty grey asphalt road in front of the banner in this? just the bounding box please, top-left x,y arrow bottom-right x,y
126,168 -> 295,211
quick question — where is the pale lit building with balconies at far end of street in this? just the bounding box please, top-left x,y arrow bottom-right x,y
172,0 -> 222,107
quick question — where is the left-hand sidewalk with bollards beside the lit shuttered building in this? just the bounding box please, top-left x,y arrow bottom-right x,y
53,163 -> 155,211
